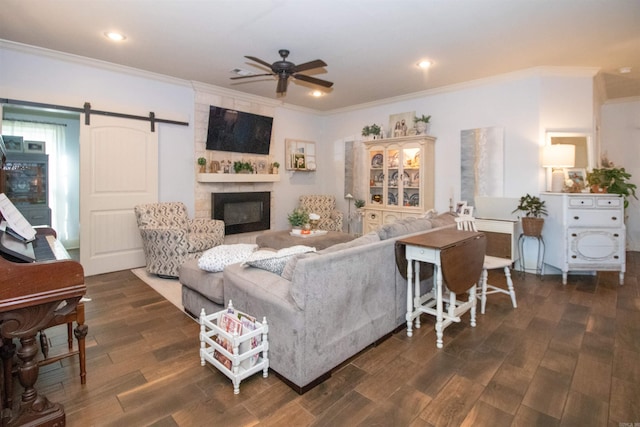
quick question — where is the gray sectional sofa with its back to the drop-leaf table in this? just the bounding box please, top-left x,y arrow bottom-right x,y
223,214 -> 455,393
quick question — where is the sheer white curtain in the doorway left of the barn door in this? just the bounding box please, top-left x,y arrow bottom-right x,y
2,119 -> 80,248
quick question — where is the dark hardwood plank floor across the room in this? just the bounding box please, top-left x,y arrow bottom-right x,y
26,252 -> 640,427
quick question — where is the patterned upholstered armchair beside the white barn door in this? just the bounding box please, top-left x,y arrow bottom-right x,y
134,202 -> 224,277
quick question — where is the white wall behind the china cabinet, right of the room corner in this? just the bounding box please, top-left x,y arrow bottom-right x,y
325,70 -> 593,219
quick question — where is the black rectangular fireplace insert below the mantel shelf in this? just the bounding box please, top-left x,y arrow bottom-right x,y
211,191 -> 271,235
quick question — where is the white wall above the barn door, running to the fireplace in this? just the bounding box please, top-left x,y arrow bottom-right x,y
0,42 -> 195,212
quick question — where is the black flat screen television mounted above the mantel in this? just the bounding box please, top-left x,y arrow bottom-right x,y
207,105 -> 273,154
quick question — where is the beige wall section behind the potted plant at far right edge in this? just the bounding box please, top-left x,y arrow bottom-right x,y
600,99 -> 640,251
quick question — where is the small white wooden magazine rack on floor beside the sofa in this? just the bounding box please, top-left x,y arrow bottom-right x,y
199,300 -> 269,394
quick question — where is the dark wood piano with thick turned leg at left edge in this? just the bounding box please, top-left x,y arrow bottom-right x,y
0,231 -> 86,426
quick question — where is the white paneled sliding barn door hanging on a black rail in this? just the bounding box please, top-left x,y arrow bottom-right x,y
80,115 -> 158,276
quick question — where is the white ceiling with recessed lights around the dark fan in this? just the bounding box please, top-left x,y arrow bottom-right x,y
0,0 -> 640,111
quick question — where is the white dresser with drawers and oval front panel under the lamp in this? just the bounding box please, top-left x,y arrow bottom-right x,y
540,193 -> 626,285
